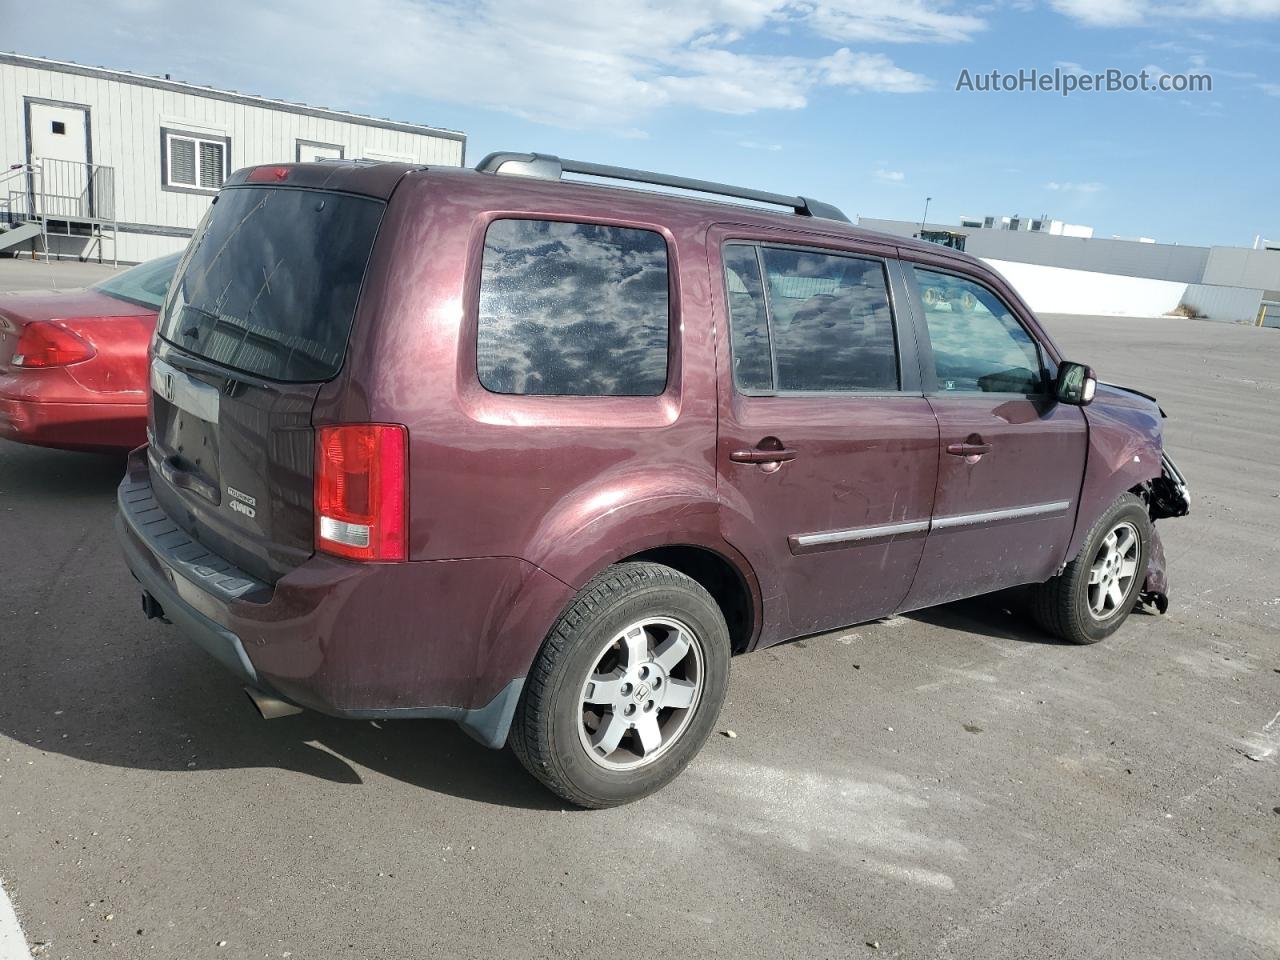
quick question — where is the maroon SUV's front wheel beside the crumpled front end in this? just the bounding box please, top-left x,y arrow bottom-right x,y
1032,493 -> 1151,644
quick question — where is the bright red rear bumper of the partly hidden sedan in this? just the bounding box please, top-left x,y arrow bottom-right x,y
0,393 -> 147,451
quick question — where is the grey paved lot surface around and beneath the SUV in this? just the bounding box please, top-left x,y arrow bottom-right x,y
0,261 -> 1280,960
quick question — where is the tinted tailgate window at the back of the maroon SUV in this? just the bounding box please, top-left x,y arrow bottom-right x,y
160,187 -> 385,383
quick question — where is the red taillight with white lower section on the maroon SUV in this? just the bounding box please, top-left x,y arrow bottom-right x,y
315,424 -> 408,561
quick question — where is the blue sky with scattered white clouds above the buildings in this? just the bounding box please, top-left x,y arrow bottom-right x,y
10,0 -> 1280,246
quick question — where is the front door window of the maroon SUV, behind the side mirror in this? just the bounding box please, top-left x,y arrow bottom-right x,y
915,268 -> 1044,394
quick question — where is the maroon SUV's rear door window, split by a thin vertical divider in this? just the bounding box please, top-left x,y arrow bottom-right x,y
724,244 -> 899,392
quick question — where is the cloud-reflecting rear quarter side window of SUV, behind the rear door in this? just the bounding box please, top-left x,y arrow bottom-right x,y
476,220 -> 669,397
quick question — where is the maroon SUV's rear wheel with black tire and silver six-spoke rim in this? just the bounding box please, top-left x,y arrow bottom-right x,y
511,563 -> 730,808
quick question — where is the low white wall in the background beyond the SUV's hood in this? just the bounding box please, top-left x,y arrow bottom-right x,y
983,257 -> 1187,316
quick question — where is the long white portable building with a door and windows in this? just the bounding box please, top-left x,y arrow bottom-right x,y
0,54 -> 466,262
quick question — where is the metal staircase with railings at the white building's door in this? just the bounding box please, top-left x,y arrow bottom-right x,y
0,159 -> 119,264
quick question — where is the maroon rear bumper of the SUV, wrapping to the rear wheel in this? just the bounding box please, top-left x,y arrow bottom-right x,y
116,451 -> 571,746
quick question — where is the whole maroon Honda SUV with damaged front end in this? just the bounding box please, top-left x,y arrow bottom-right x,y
119,154 -> 1187,806
